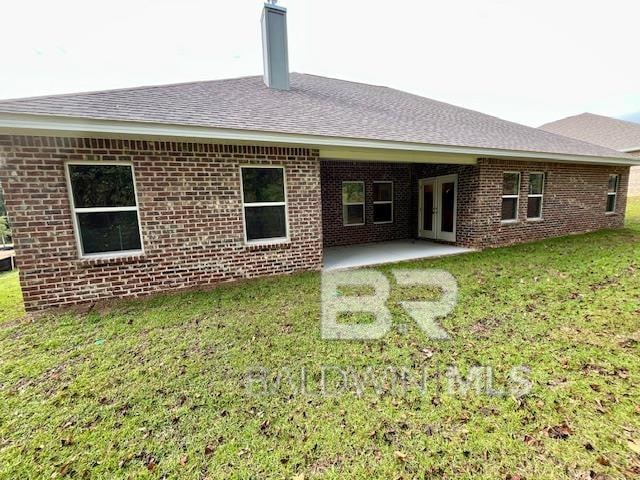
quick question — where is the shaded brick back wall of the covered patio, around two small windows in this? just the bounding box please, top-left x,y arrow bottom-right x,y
320,161 -> 412,247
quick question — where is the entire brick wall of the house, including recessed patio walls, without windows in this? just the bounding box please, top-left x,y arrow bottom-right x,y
0,136 -> 629,311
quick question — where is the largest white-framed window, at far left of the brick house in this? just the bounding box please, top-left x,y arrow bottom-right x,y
67,162 -> 142,256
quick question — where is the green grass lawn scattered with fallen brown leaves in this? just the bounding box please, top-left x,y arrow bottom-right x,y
0,201 -> 640,480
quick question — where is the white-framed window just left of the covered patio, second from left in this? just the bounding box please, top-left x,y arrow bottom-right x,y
241,167 -> 288,243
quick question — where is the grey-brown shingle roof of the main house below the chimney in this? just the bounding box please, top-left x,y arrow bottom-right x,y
0,73 -> 625,158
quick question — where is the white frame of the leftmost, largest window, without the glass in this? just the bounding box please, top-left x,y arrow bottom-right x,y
64,160 -> 144,259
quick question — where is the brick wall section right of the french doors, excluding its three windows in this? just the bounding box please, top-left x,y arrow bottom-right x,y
464,159 -> 629,247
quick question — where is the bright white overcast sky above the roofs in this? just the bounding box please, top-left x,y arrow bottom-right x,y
0,0 -> 640,126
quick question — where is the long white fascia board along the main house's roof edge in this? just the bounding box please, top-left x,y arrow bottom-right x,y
0,113 -> 640,165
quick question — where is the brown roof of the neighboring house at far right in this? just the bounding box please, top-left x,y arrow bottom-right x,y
540,113 -> 640,152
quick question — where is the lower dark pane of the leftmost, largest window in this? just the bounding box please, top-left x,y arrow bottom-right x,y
77,212 -> 141,253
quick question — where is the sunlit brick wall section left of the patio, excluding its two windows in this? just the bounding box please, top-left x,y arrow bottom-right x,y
0,136 -> 322,311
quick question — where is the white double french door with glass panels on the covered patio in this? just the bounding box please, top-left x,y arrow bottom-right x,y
418,175 -> 458,242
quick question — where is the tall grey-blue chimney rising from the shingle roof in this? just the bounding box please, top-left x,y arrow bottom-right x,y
260,0 -> 289,90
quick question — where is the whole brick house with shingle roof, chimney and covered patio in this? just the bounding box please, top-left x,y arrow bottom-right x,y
0,5 -> 638,311
